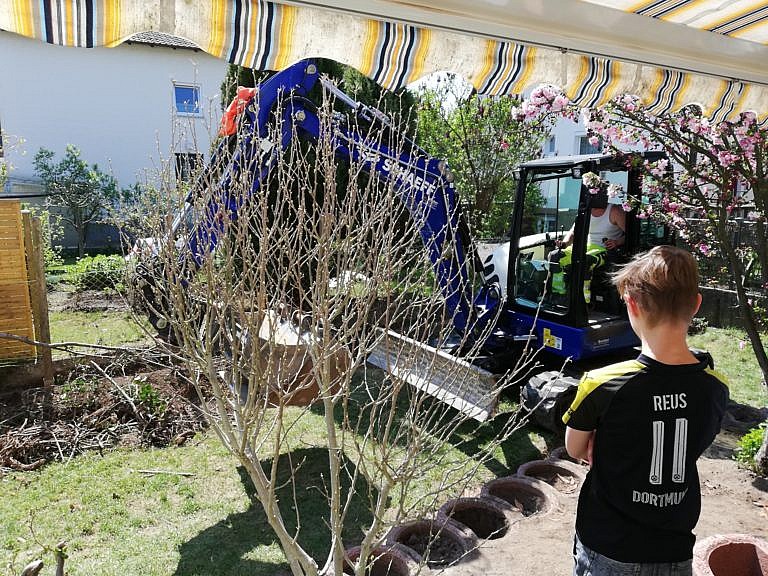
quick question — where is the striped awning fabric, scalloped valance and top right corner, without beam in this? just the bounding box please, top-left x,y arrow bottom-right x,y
0,0 -> 768,120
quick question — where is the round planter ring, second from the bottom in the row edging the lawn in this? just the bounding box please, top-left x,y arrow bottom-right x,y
386,520 -> 476,568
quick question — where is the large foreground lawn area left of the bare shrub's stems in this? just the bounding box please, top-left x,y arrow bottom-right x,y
0,437 -> 270,576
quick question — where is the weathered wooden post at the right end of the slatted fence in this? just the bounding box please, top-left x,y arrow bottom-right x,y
22,210 -> 53,386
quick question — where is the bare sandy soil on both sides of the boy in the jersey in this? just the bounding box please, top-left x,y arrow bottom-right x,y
444,431 -> 768,576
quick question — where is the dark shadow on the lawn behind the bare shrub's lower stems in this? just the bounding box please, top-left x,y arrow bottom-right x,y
174,448 -> 376,576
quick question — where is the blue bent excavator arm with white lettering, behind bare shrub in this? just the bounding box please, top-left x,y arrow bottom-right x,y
179,61 -> 471,332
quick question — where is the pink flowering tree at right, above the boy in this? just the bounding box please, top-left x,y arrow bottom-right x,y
521,86 -> 768,380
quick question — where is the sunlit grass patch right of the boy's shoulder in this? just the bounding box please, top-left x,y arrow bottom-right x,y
688,328 -> 768,407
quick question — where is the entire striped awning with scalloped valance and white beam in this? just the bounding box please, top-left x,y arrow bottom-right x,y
0,0 -> 768,120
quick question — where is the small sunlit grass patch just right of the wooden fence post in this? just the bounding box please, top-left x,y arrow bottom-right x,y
49,311 -> 147,346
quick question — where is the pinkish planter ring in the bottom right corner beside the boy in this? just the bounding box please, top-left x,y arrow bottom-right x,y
693,534 -> 768,576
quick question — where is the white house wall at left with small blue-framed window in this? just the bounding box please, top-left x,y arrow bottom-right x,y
0,32 -> 226,188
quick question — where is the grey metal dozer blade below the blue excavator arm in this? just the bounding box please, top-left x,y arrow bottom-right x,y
368,330 -> 500,422
